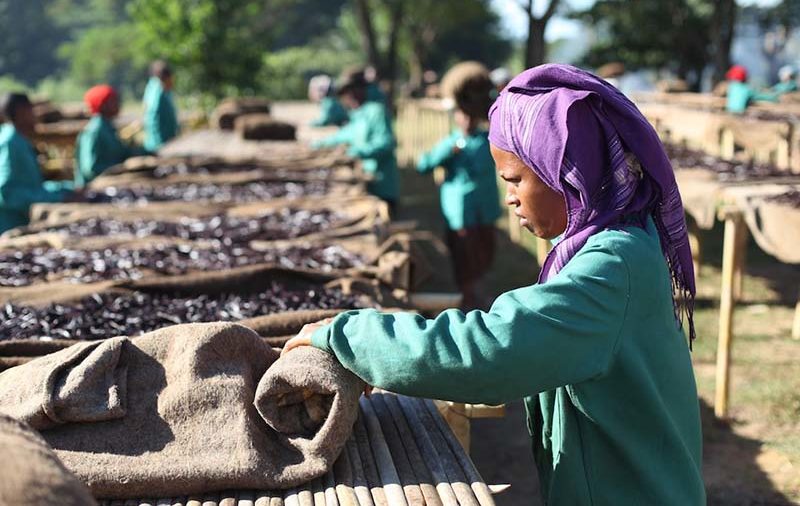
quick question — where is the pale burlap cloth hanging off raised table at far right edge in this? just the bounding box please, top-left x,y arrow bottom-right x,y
723,179 -> 800,264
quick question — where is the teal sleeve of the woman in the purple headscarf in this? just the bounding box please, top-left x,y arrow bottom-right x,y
312,237 -> 630,404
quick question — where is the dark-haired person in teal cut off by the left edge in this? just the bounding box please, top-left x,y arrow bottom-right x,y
0,93 -> 72,232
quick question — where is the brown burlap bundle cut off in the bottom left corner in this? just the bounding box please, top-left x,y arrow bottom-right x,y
0,415 -> 97,506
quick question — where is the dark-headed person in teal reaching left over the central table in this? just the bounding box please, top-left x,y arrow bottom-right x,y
314,71 -> 400,211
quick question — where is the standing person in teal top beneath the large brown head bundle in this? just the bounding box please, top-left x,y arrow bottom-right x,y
417,107 -> 501,309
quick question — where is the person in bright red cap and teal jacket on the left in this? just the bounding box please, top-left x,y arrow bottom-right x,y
75,84 -> 146,187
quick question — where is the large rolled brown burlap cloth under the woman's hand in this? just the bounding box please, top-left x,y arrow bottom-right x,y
0,323 -> 364,498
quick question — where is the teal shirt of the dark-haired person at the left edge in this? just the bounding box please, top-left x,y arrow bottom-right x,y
0,123 -> 72,233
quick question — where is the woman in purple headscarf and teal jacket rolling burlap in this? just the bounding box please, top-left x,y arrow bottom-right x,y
285,65 -> 705,505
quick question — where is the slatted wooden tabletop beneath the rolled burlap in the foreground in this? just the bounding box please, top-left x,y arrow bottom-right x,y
94,393 -> 494,506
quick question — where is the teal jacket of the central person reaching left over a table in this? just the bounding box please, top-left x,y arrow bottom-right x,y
315,102 -> 400,201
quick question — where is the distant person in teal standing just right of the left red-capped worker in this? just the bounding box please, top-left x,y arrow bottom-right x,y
144,60 -> 180,152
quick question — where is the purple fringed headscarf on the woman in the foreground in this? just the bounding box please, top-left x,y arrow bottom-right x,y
489,65 -> 695,339
